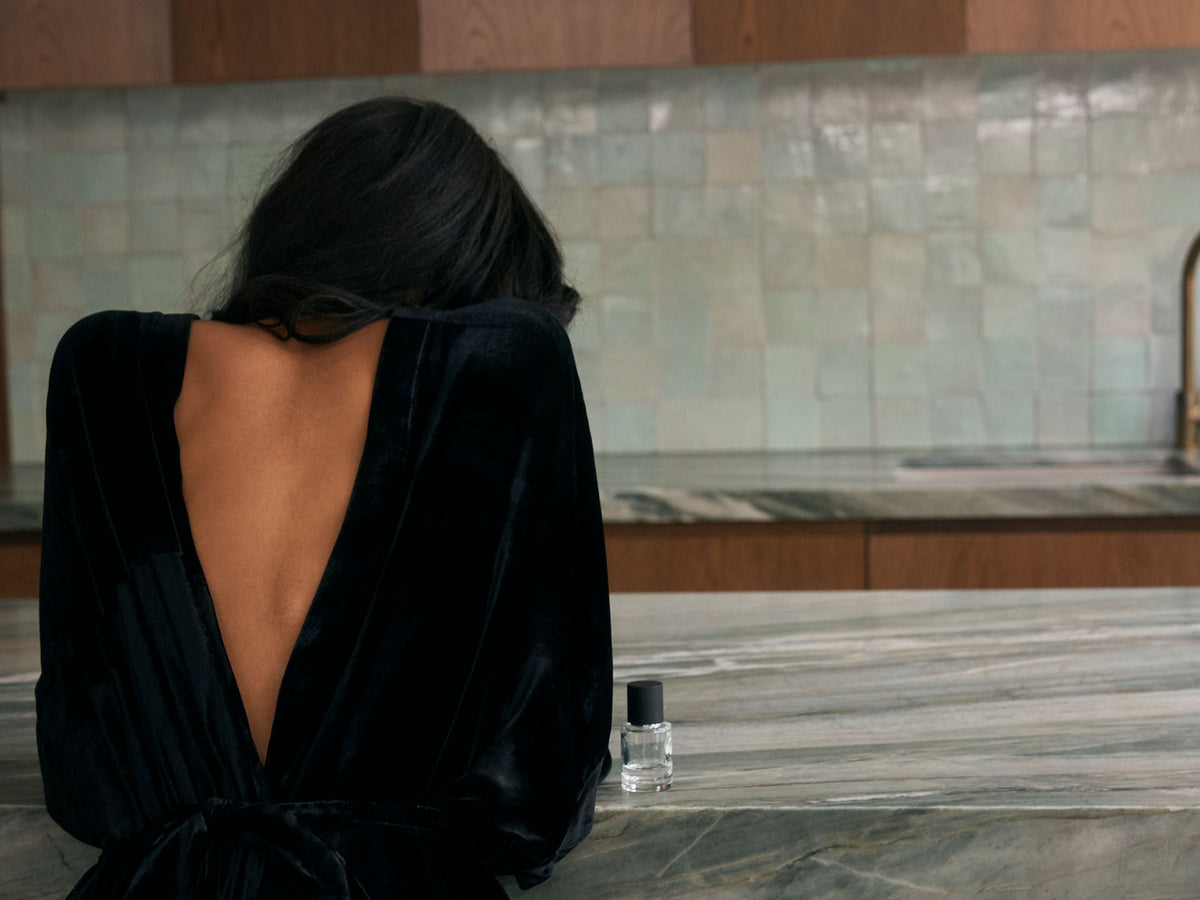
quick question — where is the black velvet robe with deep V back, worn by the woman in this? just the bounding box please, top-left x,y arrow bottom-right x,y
37,300 -> 612,900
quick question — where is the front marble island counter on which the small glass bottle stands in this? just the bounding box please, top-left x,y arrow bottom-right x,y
0,589 -> 1200,900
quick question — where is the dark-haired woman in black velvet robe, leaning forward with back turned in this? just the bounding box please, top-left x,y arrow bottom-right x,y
37,100 -> 612,900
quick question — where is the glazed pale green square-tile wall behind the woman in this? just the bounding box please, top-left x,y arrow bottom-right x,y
0,50 -> 1200,461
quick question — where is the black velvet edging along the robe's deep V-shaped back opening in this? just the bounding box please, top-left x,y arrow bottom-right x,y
167,317 -> 394,770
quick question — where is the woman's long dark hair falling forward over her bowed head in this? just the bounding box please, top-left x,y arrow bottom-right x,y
210,97 -> 580,343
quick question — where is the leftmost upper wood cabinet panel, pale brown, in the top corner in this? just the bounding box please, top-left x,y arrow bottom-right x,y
0,0 -> 170,89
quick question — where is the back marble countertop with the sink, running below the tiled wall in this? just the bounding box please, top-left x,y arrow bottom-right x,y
7,448 -> 1200,533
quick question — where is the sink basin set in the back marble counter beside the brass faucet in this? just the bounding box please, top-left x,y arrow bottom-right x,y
896,455 -> 1200,485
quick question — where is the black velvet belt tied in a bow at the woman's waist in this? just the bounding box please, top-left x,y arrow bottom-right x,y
75,797 -> 444,900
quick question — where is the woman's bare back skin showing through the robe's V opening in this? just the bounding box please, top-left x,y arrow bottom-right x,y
175,320 -> 388,762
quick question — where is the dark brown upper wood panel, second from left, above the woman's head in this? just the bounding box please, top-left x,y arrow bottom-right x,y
172,0 -> 418,82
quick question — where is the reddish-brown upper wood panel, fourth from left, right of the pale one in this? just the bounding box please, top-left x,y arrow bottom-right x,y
695,0 -> 966,64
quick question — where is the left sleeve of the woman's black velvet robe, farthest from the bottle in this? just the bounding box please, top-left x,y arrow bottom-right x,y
36,314 -> 141,846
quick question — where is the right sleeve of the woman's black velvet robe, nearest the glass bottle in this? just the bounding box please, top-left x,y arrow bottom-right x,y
429,301 -> 612,888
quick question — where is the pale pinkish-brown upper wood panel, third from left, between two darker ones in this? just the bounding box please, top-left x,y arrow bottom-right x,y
421,0 -> 692,72
